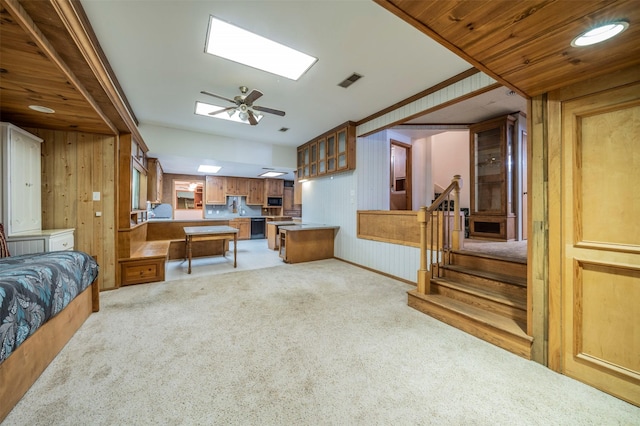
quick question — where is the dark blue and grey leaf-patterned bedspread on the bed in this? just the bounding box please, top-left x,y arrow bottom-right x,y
0,251 -> 98,363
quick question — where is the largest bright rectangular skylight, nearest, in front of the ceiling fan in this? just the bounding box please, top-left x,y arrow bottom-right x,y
205,16 -> 318,80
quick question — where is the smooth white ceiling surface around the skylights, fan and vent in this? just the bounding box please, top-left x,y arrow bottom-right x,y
81,0 -> 526,178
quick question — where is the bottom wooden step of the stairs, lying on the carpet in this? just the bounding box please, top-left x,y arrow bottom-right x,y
408,290 -> 533,359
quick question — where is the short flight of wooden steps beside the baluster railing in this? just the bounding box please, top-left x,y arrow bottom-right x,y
408,250 -> 533,359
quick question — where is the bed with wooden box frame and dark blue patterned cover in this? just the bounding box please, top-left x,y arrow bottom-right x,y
0,251 -> 99,422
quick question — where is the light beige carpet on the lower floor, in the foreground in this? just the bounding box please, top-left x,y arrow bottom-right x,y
6,260 -> 640,425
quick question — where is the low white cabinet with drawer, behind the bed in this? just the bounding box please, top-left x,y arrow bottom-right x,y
7,228 -> 74,256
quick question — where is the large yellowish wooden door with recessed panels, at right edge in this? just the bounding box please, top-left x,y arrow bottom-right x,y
549,81 -> 640,405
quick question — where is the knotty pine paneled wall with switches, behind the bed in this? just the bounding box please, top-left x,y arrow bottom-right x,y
26,128 -> 118,290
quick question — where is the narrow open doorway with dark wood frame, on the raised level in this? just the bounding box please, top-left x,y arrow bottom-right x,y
389,139 -> 413,210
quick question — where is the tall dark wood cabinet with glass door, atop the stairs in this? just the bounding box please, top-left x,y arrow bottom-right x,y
469,115 -> 517,240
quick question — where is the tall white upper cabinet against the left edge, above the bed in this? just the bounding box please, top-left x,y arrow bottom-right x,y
0,123 -> 42,237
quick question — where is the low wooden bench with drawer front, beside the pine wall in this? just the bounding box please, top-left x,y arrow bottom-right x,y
120,240 -> 171,285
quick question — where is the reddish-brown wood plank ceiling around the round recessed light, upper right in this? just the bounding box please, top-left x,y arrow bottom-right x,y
375,0 -> 640,96
